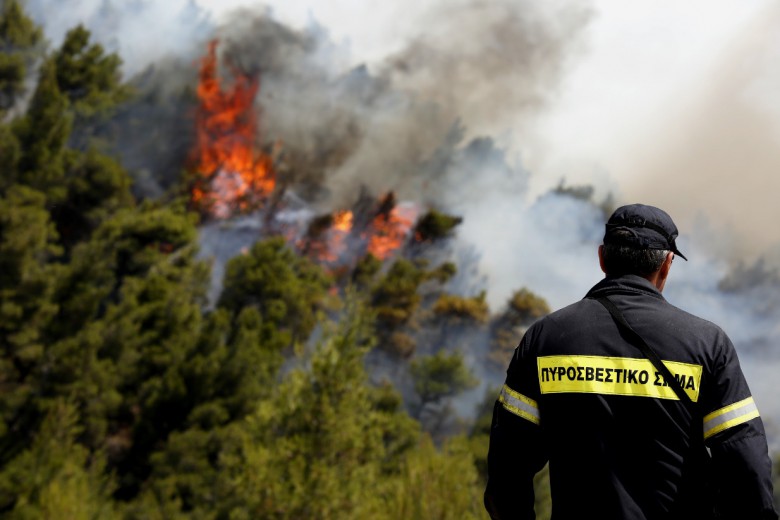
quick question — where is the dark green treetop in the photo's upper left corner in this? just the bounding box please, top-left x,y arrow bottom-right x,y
0,0 -> 42,114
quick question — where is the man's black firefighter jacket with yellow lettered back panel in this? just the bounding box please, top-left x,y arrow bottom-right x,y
485,275 -> 777,520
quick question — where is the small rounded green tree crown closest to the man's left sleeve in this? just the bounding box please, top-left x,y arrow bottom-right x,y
410,351 -> 478,403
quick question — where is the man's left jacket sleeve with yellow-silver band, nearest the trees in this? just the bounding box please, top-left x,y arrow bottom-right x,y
485,333 -> 547,520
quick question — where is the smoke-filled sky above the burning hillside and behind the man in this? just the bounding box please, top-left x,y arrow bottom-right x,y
28,0 -> 780,439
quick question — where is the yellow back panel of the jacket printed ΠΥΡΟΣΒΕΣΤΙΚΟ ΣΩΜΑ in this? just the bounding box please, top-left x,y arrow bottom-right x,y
537,356 -> 702,402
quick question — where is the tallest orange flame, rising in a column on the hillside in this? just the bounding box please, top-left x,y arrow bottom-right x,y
192,40 -> 275,218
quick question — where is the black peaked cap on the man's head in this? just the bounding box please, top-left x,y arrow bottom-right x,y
604,204 -> 688,260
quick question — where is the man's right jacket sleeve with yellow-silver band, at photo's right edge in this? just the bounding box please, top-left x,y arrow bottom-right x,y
702,338 -> 778,520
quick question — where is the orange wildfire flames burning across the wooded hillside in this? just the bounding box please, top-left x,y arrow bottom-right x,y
187,40 -> 417,268
